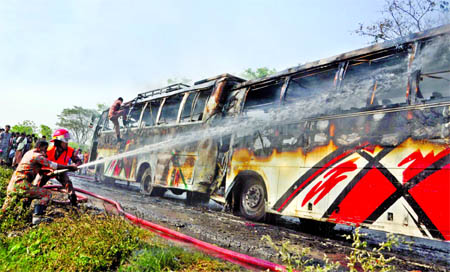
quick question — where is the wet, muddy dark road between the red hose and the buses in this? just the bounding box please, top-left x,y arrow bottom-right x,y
68,175 -> 450,271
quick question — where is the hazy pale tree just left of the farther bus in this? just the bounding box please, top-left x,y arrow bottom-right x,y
56,106 -> 98,144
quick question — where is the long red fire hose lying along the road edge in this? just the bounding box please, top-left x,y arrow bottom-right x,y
45,185 -> 286,271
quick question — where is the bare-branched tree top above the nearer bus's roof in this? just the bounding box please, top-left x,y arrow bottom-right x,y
354,0 -> 450,42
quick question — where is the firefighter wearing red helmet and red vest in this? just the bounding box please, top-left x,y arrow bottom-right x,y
37,128 -> 82,206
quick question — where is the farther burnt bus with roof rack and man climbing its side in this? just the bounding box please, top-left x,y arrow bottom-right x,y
90,74 -> 244,201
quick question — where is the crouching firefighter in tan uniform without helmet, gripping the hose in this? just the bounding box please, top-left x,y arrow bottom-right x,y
2,141 -> 78,224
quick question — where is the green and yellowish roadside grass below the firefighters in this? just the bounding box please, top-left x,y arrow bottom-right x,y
0,168 -> 240,271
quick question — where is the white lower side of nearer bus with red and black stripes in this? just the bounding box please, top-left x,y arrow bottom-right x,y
256,105 -> 450,240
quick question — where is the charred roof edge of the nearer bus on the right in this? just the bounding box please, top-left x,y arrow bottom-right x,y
234,24 -> 450,89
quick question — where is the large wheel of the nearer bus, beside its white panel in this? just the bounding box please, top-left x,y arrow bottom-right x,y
239,178 -> 266,221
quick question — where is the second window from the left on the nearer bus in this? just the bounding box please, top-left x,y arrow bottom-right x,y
285,69 -> 336,103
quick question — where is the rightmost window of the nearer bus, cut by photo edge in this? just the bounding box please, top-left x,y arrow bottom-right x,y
416,37 -> 450,102
